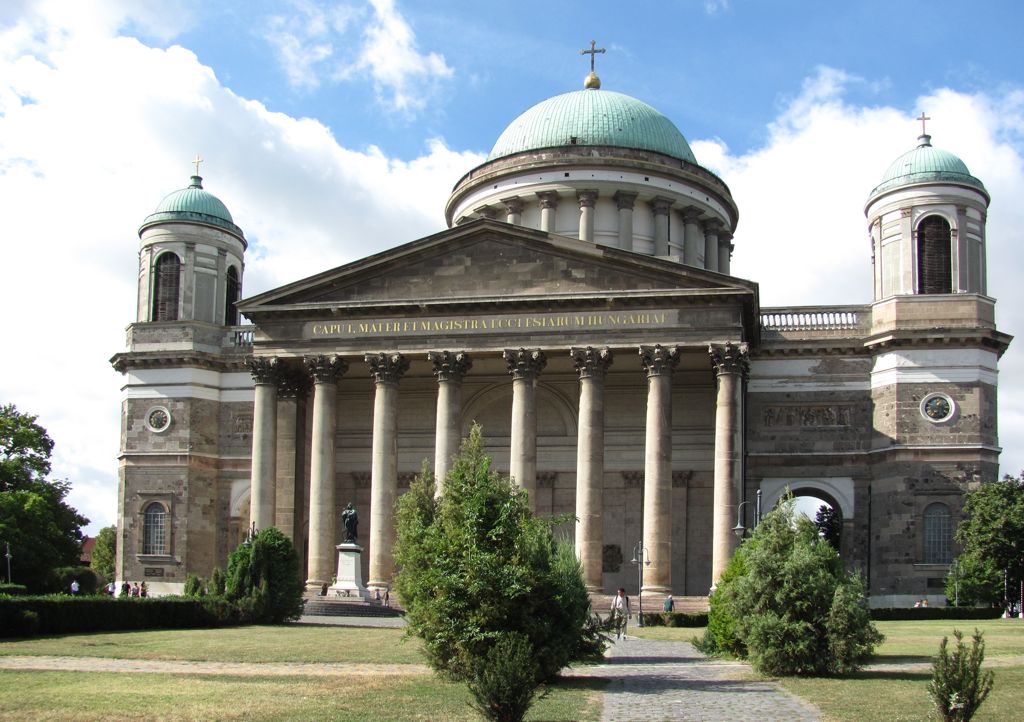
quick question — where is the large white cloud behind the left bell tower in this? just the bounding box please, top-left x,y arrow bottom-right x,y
0,7 -> 480,528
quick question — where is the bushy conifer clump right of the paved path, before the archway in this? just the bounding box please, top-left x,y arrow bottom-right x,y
700,500 -> 883,675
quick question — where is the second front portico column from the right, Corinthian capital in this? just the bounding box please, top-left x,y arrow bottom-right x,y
640,345 -> 679,593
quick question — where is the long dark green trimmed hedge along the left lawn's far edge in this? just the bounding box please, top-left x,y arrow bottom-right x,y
0,595 -> 243,637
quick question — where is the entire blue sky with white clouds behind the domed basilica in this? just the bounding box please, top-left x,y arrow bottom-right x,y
0,0 -> 1024,530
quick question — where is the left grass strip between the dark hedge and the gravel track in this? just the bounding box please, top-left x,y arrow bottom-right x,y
0,625 -> 424,665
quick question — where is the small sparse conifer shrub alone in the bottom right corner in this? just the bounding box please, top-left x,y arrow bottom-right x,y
928,629 -> 993,722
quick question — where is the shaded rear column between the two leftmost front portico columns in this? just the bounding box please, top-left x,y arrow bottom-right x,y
273,369 -> 309,549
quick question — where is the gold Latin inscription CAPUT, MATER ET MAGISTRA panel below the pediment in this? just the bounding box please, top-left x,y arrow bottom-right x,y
306,311 -> 669,338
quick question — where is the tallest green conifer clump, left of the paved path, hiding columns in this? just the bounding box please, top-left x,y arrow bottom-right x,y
395,425 -> 605,720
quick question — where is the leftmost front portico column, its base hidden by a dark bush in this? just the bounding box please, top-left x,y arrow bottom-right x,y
248,356 -> 281,530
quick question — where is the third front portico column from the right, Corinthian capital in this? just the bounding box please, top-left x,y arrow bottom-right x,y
569,346 -> 611,592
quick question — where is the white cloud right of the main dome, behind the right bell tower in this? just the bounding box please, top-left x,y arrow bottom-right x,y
692,68 -> 1024,473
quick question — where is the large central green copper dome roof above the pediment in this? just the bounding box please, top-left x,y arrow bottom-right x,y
487,88 -> 697,164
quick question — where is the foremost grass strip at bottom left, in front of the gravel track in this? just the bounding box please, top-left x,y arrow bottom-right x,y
0,671 -> 601,722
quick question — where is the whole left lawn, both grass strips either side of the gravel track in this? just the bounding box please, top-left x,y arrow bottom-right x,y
0,625 -> 604,721
